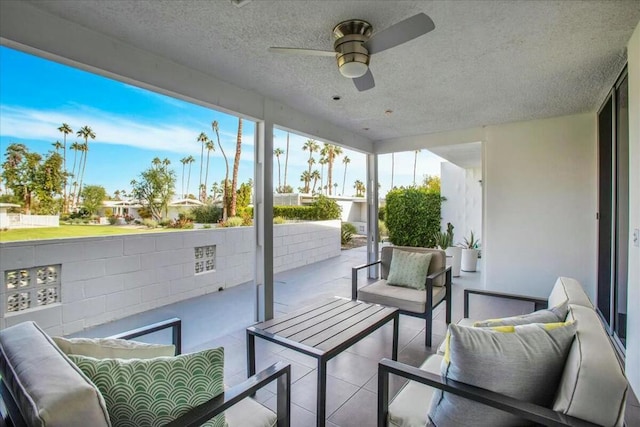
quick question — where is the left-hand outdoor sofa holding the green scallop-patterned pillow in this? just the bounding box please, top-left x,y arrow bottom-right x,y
0,319 -> 291,427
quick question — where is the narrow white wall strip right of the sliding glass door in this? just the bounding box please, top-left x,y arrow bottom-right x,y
626,19 -> 640,402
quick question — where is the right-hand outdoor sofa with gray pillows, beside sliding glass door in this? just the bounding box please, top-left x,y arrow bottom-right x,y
378,277 -> 628,427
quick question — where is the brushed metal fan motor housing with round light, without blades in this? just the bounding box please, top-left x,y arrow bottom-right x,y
333,19 -> 372,79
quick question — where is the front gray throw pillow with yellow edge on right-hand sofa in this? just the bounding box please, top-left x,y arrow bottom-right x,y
429,322 -> 576,427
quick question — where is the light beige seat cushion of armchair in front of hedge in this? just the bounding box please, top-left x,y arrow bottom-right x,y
358,280 -> 447,313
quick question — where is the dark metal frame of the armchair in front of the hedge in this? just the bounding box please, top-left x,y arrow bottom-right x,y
351,260 -> 451,347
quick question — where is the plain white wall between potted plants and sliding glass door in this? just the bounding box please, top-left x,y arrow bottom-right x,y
482,113 -> 597,301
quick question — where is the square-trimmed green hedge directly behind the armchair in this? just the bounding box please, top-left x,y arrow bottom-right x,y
386,188 -> 442,248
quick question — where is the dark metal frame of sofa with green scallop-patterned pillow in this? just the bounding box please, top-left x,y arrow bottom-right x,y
0,318 -> 291,427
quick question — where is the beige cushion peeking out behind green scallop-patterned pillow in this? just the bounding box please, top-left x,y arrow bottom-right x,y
53,337 -> 176,359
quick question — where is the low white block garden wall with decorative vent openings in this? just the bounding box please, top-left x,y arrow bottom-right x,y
0,220 -> 340,335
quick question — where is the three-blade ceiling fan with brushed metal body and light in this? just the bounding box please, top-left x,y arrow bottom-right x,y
269,13 -> 436,92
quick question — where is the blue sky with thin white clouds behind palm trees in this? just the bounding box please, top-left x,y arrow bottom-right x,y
0,47 -> 442,199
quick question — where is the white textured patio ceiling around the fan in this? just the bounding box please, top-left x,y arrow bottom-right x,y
22,0 -> 640,144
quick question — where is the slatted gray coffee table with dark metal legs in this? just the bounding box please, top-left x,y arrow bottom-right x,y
247,297 -> 399,427
